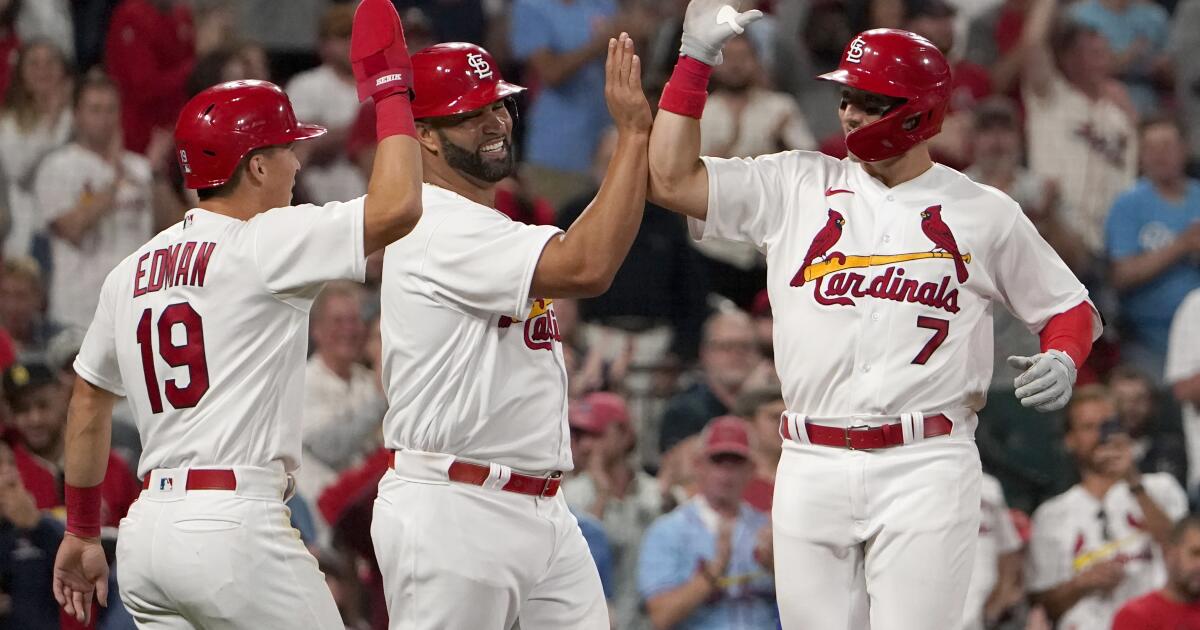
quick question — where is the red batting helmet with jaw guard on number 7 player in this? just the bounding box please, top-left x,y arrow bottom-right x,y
817,29 -> 950,162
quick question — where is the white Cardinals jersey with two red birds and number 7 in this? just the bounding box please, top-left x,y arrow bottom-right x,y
689,151 -> 1100,427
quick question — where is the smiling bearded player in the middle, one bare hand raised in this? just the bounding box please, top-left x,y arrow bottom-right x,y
371,34 -> 652,630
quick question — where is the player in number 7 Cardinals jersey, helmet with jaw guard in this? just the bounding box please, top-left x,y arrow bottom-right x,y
649,0 -> 1100,630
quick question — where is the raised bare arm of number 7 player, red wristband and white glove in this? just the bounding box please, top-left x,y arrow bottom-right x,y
649,0 -> 762,220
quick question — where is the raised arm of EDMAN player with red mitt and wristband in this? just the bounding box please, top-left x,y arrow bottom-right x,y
350,0 -> 421,253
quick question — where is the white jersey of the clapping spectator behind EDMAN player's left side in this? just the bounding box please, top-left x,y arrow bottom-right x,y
34,144 -> 154,328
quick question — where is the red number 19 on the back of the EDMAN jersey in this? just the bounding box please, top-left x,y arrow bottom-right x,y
138,302 -> 209,414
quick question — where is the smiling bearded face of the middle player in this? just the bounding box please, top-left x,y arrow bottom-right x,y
431,101 -> 516,184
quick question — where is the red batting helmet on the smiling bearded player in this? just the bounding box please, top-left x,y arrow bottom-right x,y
413,42 -> 524,119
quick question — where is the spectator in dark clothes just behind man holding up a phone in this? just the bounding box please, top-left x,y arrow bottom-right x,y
1109,365 -> 1188,487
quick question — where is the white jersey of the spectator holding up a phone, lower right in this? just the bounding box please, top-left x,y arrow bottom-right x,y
1025,473 -> 1188,630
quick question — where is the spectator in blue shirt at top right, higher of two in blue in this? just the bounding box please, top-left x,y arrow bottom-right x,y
1068,0 -> 1169,116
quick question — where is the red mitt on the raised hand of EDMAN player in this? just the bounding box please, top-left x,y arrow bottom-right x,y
350,0 -> 413,103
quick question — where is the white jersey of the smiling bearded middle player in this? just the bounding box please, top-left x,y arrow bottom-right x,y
380,184 -> 571,472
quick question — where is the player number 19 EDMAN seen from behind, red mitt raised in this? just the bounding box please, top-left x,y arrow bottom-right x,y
54,0 -> 421,629
